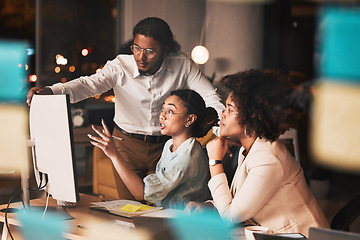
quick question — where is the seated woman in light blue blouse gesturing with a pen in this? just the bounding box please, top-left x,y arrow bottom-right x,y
89,89 -> 218,209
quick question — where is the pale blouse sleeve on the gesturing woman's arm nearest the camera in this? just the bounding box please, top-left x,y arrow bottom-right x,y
143,151 -> 190,203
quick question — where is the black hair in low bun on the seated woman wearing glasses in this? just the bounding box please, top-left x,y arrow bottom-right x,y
170,89 -> 219,137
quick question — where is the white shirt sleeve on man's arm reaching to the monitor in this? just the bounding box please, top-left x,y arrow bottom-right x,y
50,61 -> 121,103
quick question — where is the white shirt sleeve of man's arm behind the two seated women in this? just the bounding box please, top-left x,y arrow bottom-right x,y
188,59 -> 225,116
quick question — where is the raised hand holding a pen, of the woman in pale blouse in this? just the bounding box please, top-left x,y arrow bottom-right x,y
88,120 -> 118,158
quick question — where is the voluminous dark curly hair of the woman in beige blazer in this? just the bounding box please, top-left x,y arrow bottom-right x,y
220,69 -> 298,141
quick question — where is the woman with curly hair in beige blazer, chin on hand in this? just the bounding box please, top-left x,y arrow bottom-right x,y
187,69 -> 328,236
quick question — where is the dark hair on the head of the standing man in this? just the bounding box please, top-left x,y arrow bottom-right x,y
133,17 -> 181,52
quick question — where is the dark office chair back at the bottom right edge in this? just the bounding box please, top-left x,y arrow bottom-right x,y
330,195 -> 360,231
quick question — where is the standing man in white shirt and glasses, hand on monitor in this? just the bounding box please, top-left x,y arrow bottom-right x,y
27,17 -> 224,199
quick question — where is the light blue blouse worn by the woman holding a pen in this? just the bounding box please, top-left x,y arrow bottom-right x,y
143,137 -> 210,209
